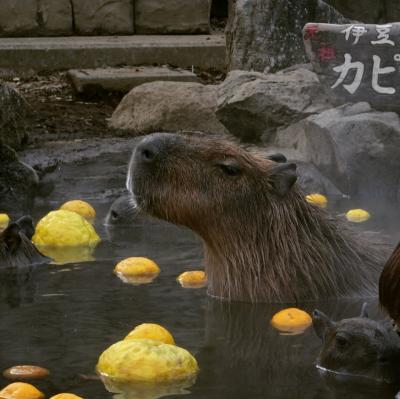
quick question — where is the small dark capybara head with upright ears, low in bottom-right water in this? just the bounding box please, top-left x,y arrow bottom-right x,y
313,304 -> 400,382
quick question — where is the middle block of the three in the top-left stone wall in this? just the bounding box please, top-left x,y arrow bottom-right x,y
72,0 -> 134,35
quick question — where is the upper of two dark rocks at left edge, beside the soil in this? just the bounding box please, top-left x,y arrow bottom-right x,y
0,84 -> 30,149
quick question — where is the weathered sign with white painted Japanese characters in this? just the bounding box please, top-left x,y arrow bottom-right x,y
303,23 -> 400,111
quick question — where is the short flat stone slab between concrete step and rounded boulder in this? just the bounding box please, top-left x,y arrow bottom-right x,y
68,66 -> 198,93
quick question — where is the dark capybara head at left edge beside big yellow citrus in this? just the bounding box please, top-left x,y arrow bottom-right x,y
0,216 -> 50,269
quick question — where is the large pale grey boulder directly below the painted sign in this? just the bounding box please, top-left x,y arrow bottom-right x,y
275,103 -> 400,203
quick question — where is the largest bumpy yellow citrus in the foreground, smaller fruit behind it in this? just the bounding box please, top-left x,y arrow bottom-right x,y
96,339 -> 199,383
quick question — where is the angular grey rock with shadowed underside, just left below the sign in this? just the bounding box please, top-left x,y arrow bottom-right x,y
217,67 -> 331,142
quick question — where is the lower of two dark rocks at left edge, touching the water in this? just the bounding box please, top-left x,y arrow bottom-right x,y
0,143 -> 54,217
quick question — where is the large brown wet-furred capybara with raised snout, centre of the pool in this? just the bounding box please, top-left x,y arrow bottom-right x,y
127,133 -> 386,302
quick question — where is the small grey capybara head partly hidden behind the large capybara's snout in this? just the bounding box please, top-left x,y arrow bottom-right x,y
104,193 -> 140,226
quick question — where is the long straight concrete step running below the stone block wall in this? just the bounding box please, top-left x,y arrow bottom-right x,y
0,35 -> 225,76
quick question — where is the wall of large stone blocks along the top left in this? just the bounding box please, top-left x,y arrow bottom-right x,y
0,0 -> 212,37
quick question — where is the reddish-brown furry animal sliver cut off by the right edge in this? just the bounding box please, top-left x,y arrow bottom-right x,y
379,244 -> 400,328
